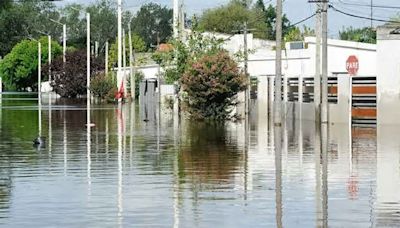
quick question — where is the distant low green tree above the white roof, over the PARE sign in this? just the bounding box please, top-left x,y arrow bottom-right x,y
339,27 -> 376,44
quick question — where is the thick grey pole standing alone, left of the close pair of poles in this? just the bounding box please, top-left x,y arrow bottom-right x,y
274,0 -> 282,126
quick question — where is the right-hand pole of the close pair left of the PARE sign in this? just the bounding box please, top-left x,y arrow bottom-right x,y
321,0 -> 329,124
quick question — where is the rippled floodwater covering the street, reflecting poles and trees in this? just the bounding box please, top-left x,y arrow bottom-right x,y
0,95 -> 400,227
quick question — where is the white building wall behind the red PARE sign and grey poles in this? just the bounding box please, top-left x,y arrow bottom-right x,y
245,37 -> 377,76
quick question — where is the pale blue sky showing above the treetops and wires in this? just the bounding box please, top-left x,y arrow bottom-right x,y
56,0 -> 400,37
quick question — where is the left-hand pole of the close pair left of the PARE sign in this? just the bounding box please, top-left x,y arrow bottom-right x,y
316,3 -> 322,123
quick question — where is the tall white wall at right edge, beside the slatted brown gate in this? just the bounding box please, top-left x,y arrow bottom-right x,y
377,27 -> 400,125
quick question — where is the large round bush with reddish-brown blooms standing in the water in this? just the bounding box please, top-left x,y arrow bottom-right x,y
181,51 -> 247,120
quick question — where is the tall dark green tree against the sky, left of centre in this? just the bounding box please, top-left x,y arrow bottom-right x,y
131,3 -> 172,48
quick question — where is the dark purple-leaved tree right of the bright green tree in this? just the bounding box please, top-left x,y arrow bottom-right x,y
47,50 -> 104,98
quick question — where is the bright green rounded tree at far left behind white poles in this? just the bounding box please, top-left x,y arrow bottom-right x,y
0,37 -> 62,91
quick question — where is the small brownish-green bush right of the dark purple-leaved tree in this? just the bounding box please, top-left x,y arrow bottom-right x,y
90,73 -> 117,100
